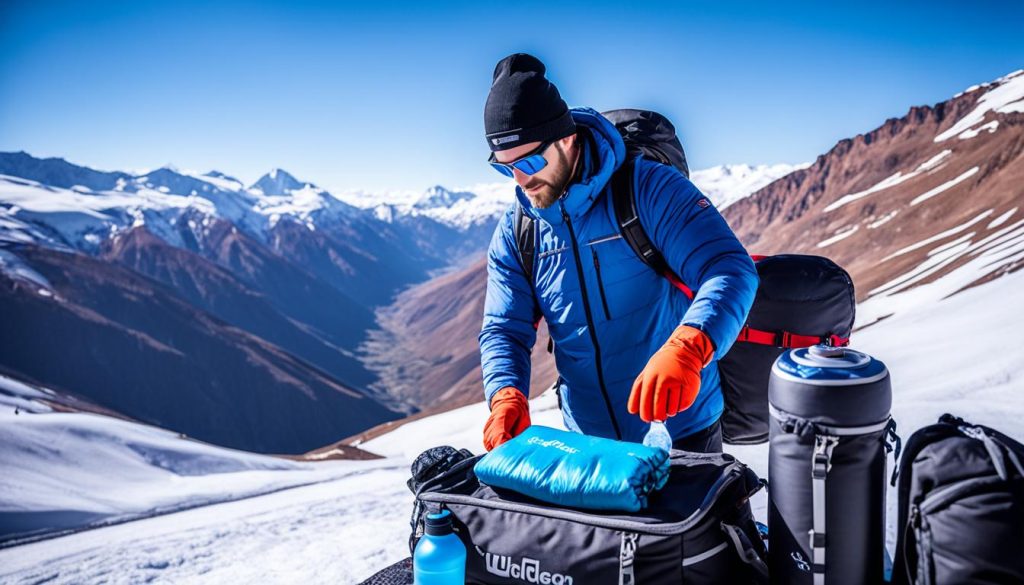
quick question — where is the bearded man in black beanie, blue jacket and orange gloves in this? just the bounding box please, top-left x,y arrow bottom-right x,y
479,53 -> 758,452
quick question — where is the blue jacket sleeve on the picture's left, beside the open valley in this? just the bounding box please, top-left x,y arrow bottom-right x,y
479,209 -> 540,405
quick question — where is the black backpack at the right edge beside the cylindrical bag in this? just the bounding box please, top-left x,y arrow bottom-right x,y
892,414 -> 1024,585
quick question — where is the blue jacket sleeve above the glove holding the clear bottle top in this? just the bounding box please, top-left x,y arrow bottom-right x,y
634,159 -> 758,360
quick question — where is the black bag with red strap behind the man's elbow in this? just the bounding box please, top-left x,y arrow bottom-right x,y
718,254 -> 856,445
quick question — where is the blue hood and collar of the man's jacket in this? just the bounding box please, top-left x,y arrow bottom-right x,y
515,108 -> 626,224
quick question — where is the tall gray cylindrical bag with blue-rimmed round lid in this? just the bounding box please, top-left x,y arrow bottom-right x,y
768,345 -> 895,585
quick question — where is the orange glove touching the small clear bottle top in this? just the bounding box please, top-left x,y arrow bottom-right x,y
627,325 -> 715,422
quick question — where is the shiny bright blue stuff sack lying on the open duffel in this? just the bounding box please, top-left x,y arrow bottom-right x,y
473,425 -> 669,512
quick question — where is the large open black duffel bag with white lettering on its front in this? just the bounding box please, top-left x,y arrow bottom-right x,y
410,451 -> 767,585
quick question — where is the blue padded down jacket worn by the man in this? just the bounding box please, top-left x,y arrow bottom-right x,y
479,109 -> 758,442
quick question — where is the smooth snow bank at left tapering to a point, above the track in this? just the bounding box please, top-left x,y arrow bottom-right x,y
0,376 -> 395,546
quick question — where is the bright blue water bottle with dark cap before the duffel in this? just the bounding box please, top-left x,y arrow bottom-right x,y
413,510 -> 466,585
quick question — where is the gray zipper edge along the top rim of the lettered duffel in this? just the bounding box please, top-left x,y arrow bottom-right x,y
419,464 -> 742,536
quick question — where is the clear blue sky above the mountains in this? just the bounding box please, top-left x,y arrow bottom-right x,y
0,0 -> 1024,191
